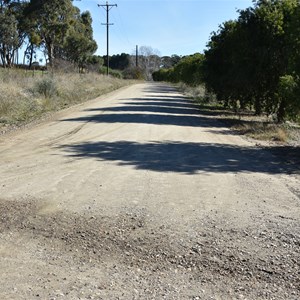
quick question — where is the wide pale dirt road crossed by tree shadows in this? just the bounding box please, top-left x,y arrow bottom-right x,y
0,83 -> 300,300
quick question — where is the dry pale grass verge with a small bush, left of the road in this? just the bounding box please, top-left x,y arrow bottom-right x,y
0,69 -> 132,133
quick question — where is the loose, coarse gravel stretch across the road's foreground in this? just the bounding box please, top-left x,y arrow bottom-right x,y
0,199 -> 300,299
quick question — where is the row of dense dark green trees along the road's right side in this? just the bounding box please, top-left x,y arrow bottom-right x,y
153,0 -> 300,122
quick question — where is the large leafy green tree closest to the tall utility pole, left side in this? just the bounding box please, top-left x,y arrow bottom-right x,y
24,0 -> 97,70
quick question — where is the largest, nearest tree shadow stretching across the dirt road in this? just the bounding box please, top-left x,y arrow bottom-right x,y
60,141 -> 300,174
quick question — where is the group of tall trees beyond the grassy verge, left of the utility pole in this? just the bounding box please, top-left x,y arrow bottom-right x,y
0,0 -> 99,68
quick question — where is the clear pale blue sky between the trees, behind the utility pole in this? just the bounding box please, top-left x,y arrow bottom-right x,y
74,0 -> 253,56
